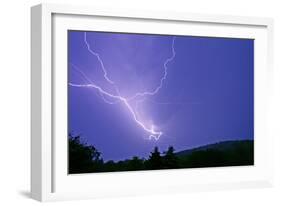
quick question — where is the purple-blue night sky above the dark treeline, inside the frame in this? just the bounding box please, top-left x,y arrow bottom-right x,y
68,31 -> 254,161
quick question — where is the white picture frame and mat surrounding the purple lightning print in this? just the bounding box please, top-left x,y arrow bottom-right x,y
31,4 -> 273,201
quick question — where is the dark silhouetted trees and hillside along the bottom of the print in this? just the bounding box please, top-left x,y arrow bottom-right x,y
68,135 -> 254,174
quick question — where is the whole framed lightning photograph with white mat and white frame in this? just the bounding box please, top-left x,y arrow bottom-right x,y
31,4 -> 273,201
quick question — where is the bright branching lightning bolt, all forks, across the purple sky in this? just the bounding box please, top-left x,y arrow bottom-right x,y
69,32 -> 176,140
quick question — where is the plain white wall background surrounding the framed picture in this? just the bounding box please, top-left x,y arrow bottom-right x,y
0,0 -> 281,206
